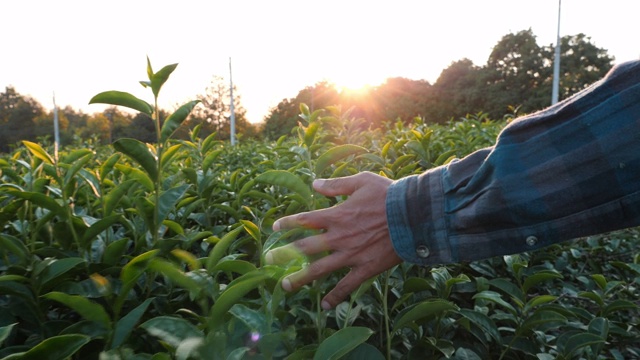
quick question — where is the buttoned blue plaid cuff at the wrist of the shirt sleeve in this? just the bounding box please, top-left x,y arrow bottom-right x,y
386,167 -> 456,265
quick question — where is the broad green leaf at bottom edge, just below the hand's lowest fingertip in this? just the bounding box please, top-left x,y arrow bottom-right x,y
313,326 -> 373,360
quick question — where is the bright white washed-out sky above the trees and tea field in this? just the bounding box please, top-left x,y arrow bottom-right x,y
0,0 -> 640,122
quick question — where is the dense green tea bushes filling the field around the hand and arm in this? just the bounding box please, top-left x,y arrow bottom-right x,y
0,63 -> 640,359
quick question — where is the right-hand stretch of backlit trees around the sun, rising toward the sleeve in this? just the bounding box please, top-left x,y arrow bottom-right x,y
262,29 -> 614,138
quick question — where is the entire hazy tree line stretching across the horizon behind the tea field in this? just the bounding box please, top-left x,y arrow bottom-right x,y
0,29 -> 614,152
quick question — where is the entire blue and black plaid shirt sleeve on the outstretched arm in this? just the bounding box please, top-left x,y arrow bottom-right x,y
386,61 -> 640,265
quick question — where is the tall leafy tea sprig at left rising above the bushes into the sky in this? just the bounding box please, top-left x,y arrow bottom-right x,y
89,57 -> 200,244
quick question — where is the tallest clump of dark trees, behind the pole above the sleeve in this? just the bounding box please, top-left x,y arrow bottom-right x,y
427,30 -> 613,121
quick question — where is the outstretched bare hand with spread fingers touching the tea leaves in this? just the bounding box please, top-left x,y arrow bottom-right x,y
266,172 -> 402,310
